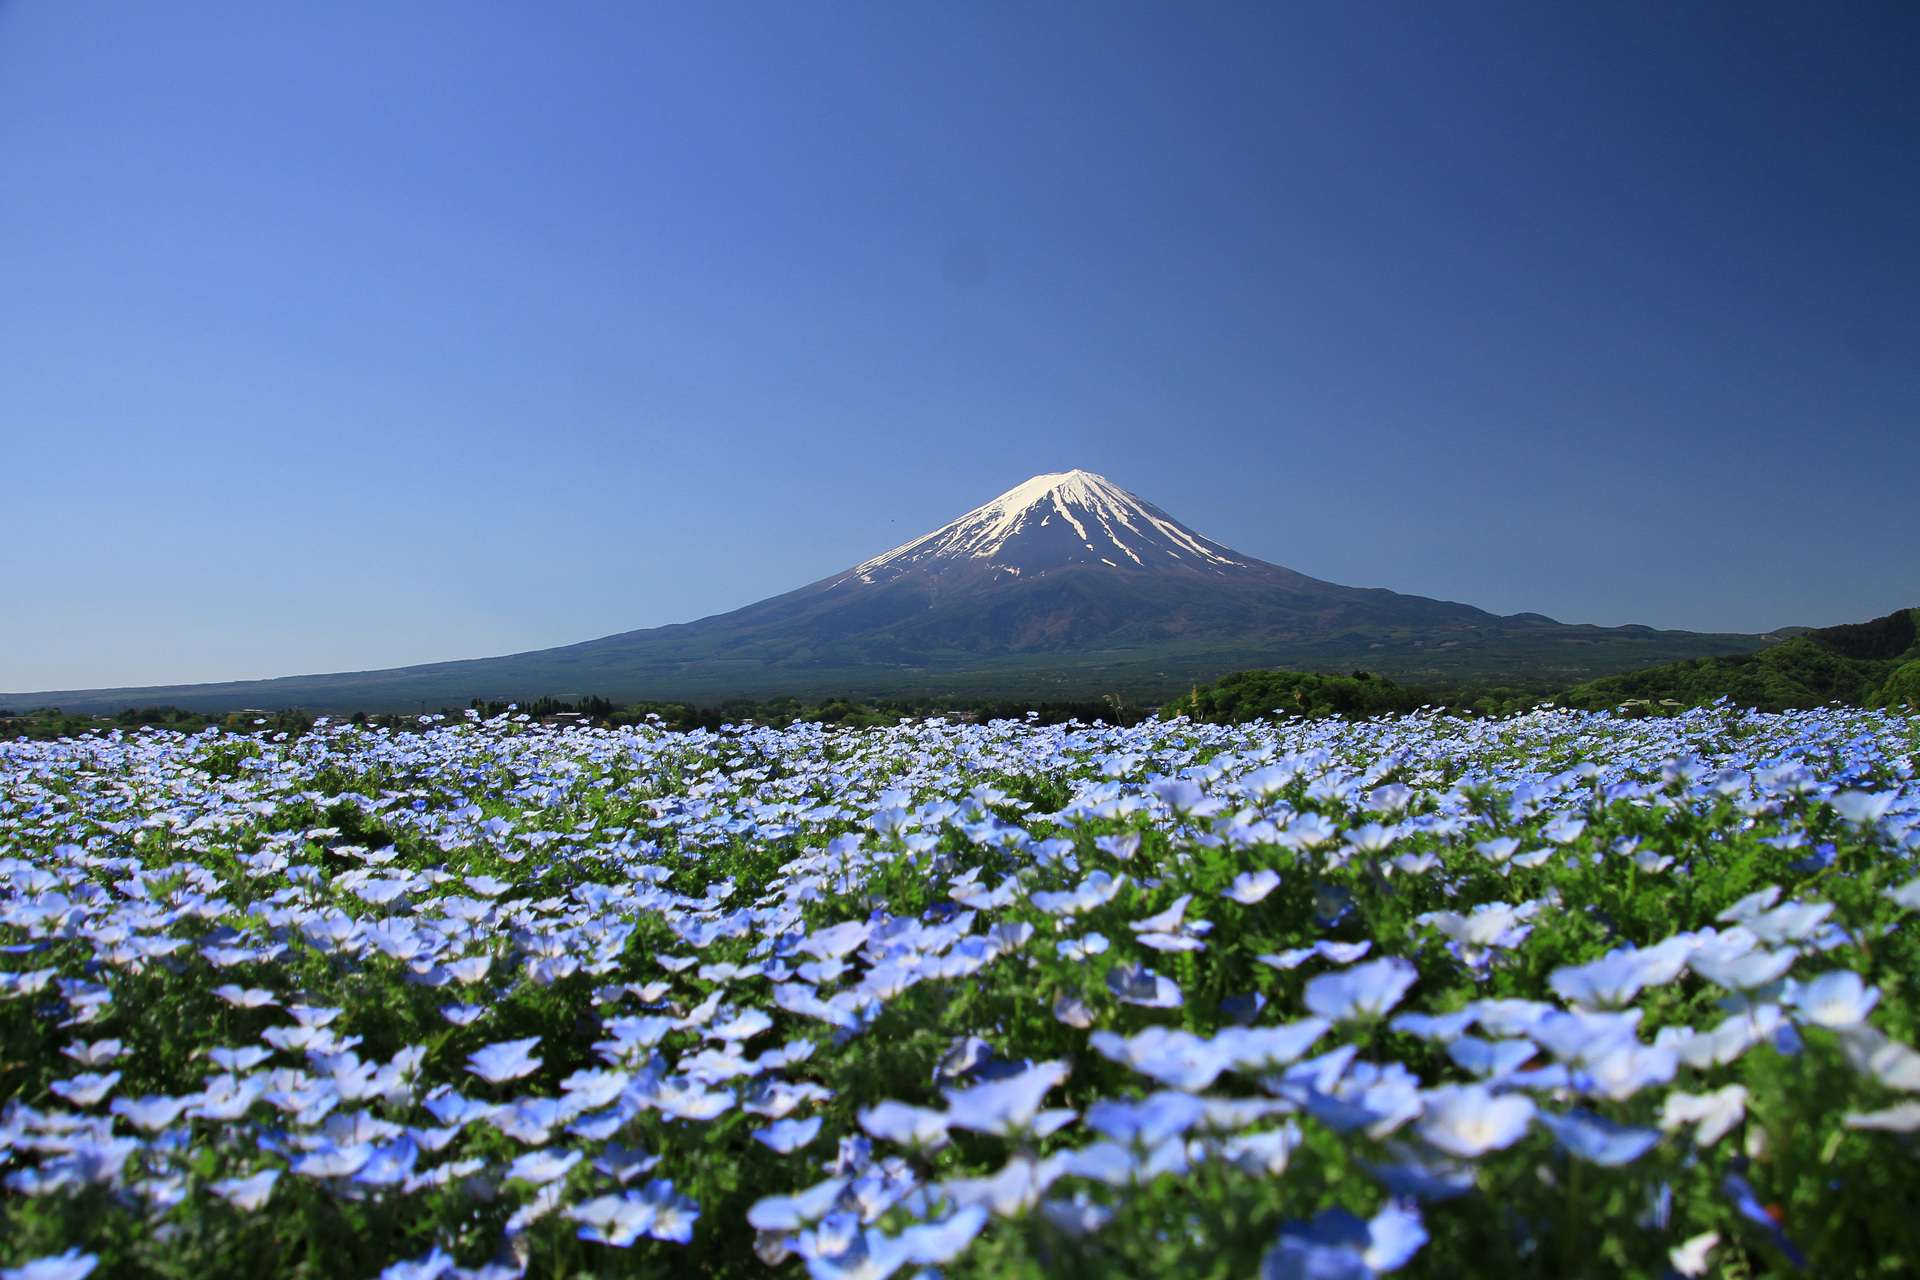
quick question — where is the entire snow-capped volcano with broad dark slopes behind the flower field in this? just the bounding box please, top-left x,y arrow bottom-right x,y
0,470 -> 1768,710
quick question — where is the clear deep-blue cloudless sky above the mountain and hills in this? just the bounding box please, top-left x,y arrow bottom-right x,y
0,0 -> 1920,689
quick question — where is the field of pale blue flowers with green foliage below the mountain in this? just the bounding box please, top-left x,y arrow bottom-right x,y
0,708 -> 1920,1280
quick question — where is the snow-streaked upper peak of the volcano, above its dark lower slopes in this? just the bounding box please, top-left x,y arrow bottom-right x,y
833,470 -> 1250,585
